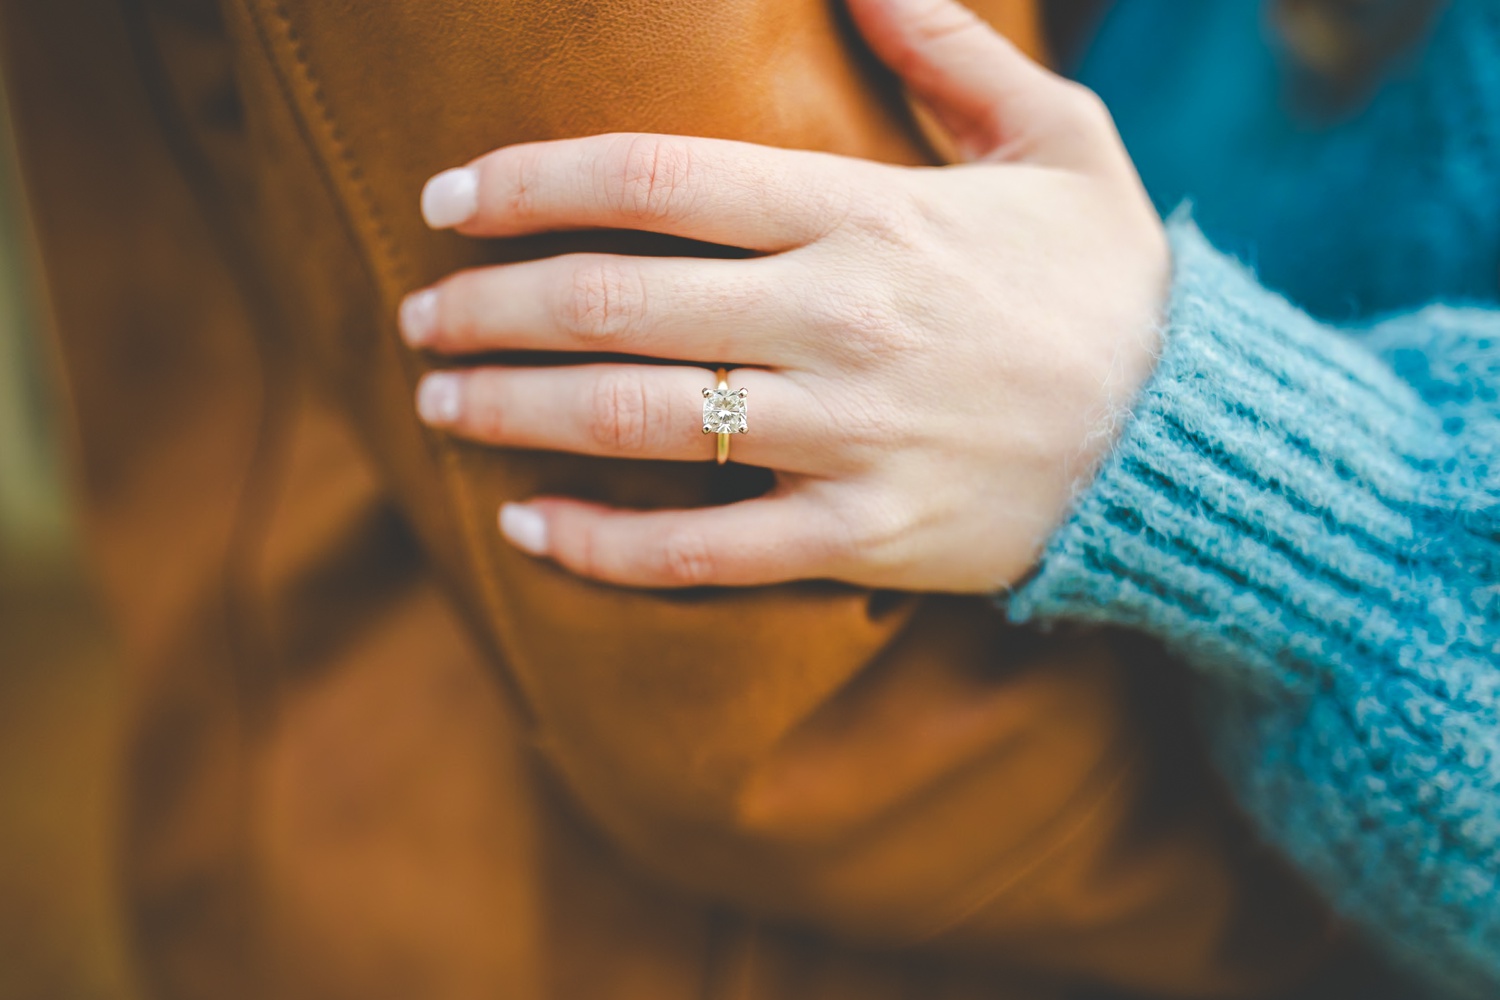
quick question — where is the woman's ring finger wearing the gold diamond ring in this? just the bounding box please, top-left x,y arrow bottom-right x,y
417,364 -> 837,472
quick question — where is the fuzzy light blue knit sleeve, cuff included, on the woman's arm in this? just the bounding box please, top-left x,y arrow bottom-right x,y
1005,217 -> 1500,997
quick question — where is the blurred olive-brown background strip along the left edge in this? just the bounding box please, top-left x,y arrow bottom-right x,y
0,102 -> 137,1000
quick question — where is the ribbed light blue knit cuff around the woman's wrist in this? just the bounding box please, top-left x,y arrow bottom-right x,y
1002,213 -> 1443,687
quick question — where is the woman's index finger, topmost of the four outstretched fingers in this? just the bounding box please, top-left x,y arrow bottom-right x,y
422,133 -> 870,252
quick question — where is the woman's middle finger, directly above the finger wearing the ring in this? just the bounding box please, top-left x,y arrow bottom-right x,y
401,253 -> 806,366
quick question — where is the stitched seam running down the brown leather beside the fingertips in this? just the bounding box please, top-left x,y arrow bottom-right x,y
240,0 -> 536,729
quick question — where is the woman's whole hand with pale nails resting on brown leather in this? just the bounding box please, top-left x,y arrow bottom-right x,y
401,0 -> 1169,592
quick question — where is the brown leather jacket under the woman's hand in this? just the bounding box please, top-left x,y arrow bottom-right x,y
5,0 -> 1370,1000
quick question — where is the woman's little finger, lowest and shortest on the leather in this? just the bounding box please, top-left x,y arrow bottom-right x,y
500,493 -> 846,588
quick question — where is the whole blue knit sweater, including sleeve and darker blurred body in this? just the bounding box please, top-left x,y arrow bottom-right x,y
1008,0 -> 1500,997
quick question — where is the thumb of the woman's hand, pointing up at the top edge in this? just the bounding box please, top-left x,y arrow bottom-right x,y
848,0 -> 1086,160
